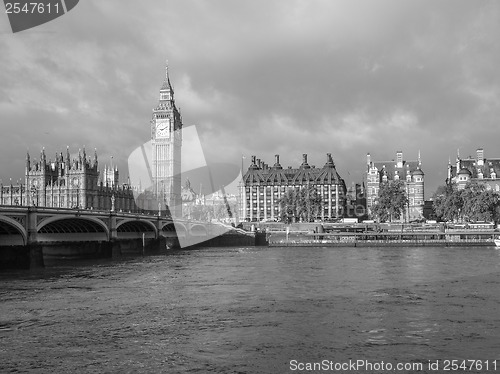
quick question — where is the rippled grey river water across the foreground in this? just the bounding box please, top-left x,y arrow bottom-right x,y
0,247 -> 500,373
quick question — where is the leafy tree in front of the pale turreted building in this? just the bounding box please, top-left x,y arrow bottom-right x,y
372,180 -> 408,222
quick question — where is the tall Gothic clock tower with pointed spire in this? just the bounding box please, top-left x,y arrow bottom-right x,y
151,63 -> 186,217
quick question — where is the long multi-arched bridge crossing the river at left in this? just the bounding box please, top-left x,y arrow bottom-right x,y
0,206 -> 255,267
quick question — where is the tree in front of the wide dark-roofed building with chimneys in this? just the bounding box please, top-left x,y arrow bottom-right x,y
279,186 -> 322,223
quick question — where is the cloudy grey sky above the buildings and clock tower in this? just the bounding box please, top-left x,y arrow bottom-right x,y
0,0 -> 500,198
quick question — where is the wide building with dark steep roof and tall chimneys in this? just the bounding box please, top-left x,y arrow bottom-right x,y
241,153 -> 346,221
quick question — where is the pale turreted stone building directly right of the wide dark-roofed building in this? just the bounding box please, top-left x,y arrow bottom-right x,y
366,151 -> 424,221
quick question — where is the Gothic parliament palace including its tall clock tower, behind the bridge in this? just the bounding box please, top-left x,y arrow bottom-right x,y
0,65 -> 182,216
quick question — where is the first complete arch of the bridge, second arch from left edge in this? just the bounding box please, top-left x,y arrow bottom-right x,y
37,216 -> 109,241
